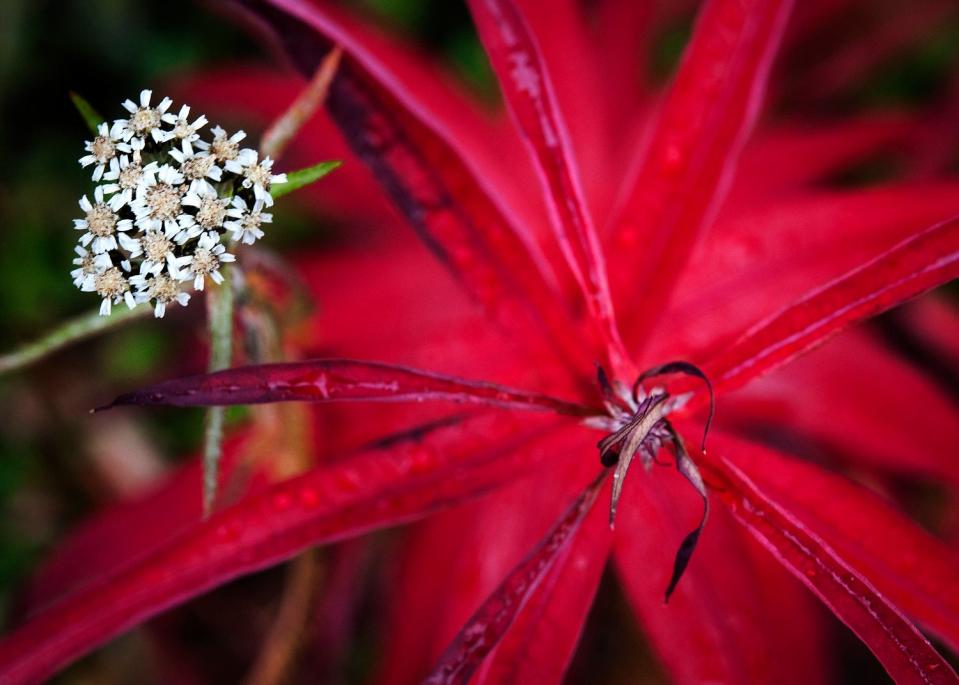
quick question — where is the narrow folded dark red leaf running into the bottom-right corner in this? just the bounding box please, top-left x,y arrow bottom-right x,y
709,458 -> 959,685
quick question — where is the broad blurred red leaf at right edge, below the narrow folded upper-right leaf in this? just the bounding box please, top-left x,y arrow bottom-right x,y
722,330 -> 959,486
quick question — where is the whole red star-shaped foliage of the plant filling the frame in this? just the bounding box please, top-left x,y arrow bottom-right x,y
0,0 -> 959,683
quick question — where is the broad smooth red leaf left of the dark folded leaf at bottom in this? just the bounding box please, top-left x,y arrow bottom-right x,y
374,428 -> 596,685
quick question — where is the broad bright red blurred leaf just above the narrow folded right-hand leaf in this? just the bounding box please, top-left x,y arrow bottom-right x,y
647,183 -> 959,363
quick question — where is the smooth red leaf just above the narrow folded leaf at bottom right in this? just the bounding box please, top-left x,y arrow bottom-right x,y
713,432 -> 959,648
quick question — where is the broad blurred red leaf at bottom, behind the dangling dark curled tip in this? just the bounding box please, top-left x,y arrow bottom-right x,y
614,462 -> 829,685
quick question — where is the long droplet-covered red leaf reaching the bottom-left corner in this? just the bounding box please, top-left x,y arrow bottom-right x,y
0,413 -> 578,683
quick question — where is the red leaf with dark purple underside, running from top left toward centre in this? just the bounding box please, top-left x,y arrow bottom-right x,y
234,0 -> 589,368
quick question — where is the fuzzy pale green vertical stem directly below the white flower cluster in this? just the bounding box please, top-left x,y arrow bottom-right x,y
203,267 -> 233,516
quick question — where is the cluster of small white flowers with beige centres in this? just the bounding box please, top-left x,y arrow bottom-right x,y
70,90 -> 287,317
